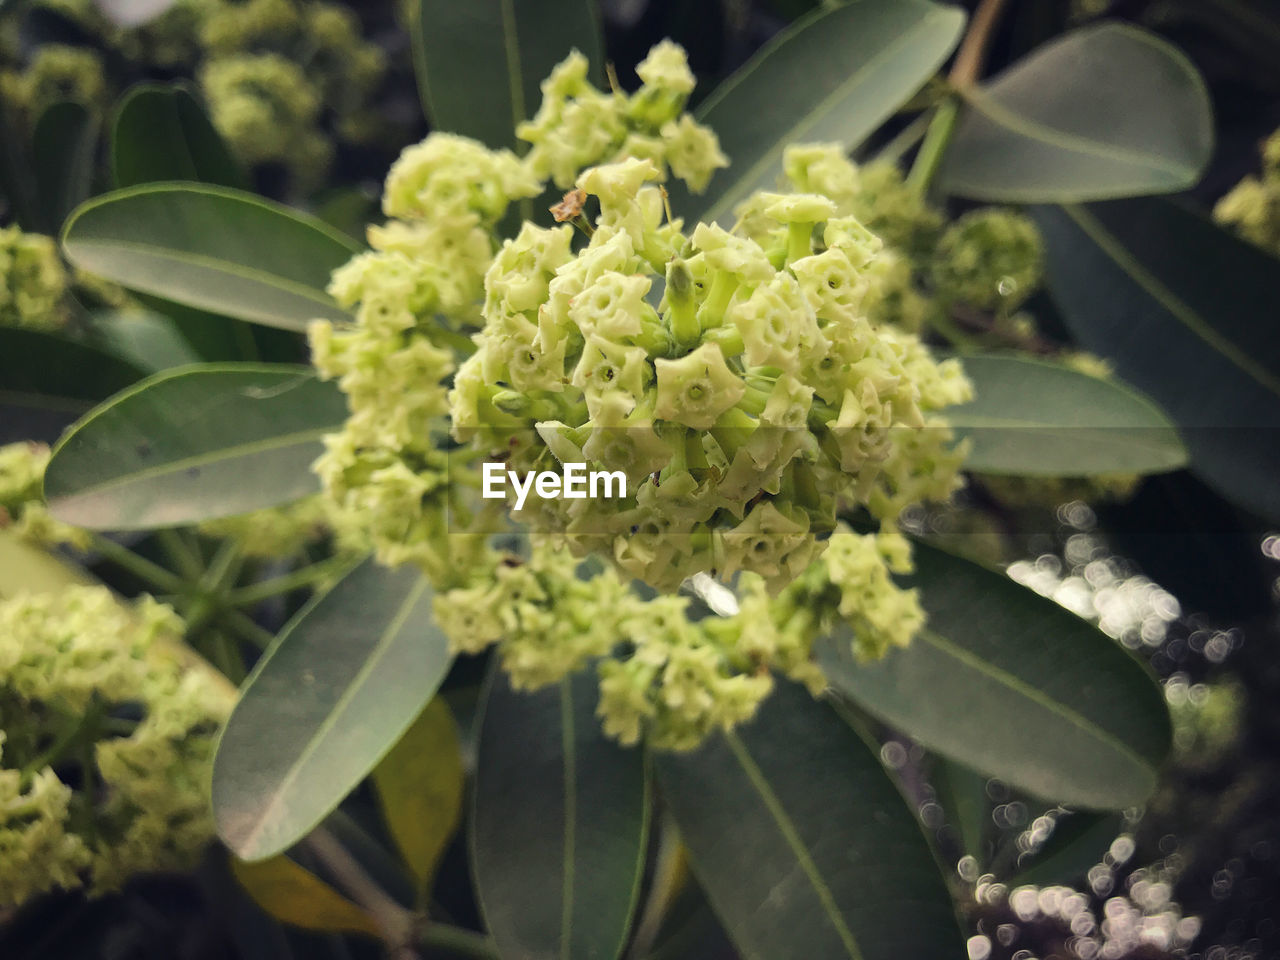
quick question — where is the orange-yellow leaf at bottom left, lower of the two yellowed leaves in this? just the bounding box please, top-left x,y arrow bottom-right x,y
232,856 -> 379,937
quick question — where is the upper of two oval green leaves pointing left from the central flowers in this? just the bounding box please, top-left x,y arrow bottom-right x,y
63,183 -> 360,330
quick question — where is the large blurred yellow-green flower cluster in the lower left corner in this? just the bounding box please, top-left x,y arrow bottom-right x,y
0,586 -> 234,906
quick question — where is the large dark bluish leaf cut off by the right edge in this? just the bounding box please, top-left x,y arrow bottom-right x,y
1033,200 -> 1280,518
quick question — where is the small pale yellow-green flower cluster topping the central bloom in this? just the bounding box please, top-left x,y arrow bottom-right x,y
516,40 -> 728,192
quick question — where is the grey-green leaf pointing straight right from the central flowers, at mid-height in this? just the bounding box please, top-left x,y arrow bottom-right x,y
946,356 -> 1187,476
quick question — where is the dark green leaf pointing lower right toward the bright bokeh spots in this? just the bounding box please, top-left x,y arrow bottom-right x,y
818,544 -> 1170,809
